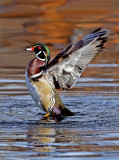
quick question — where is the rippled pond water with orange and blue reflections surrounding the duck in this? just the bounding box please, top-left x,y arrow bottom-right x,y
0,0 -> 119,160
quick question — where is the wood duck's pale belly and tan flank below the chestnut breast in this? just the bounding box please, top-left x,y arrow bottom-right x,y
25,70 -> 54,112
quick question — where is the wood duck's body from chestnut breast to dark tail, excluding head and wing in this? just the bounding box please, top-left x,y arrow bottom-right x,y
25,58 -> 73,116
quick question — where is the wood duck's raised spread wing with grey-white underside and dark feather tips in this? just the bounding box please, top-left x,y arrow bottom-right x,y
31,28 -> 107,89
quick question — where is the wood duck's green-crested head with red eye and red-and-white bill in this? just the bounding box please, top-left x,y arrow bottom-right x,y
25,43 -> 50,65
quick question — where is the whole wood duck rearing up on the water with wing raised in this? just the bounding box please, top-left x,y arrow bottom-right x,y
25,28 -> 107,117
